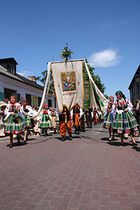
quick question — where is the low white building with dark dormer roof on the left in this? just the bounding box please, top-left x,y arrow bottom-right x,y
0,58 -> 56,107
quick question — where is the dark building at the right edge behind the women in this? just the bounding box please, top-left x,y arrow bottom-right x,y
128,65 -> 140,106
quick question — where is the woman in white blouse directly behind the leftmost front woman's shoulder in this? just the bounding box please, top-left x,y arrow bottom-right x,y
21,99 -> 32,142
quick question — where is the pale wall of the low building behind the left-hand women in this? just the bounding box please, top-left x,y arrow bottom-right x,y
0,75 -> 55,106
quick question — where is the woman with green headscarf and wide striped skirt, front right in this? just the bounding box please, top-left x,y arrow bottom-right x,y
112,90 -> 137,145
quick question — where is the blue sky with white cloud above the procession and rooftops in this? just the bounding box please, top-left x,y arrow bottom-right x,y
0,0 -> 140,97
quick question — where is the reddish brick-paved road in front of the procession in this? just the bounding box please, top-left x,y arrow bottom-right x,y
0,126 -> 140,210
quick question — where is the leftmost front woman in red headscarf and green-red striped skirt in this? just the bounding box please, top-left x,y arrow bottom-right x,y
4,96 -> 23,148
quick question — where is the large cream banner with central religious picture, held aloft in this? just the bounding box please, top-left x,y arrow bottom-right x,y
51,60 -> 84,112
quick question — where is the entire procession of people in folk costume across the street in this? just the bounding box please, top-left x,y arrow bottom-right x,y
0,91 -> 140,148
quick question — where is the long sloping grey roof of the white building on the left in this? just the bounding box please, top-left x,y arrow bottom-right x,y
0,65 -> 44,90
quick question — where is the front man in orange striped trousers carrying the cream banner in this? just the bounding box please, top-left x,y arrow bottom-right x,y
59,106 -> 72,141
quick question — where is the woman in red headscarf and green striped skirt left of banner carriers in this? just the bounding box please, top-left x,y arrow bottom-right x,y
40,104 -> 52,136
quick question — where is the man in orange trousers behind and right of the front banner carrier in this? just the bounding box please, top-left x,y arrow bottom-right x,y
73,104 -> 80,134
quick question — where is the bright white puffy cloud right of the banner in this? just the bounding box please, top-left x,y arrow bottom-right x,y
88,49 -> 122,67
